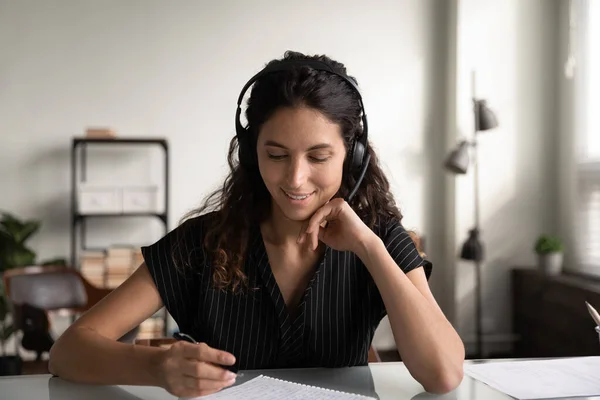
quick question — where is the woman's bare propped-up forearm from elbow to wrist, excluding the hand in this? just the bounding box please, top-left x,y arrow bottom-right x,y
357,235 -> 465,393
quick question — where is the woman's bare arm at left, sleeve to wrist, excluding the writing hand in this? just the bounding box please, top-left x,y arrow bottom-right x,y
49,264 -> 165,386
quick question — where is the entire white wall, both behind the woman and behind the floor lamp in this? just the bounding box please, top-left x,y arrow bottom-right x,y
0,0 -> 564,356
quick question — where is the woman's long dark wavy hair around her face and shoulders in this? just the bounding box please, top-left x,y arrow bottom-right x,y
184,51 -> 402,292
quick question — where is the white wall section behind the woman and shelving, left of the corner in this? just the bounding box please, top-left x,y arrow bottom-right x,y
0,0 -> 445,347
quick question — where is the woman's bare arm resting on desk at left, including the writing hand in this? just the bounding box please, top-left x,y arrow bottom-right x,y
49,263 -> 235,397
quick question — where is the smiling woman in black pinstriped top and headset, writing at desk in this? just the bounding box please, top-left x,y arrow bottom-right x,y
50,52 -> 464,397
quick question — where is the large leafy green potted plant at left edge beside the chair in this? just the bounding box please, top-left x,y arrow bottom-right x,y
0,213 -> 66,376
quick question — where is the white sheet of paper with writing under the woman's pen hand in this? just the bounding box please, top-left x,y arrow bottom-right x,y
184,375 -> 375,400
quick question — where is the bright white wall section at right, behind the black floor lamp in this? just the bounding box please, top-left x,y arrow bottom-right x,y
455,0 -> 562,351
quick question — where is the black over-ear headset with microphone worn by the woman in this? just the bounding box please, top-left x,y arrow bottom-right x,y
235,60 -> 371,201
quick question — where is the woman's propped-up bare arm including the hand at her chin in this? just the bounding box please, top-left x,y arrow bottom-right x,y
298,198 -> 465,393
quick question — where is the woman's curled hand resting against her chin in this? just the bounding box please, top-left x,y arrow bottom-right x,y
298,198 -> 376,254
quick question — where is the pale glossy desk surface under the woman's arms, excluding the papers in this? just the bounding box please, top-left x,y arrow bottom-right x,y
0,361 -> 600,400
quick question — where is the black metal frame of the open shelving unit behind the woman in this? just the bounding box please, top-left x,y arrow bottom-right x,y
71,137 -> 169,336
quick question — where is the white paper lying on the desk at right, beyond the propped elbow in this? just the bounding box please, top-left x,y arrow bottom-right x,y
464,357 -> 600,400
